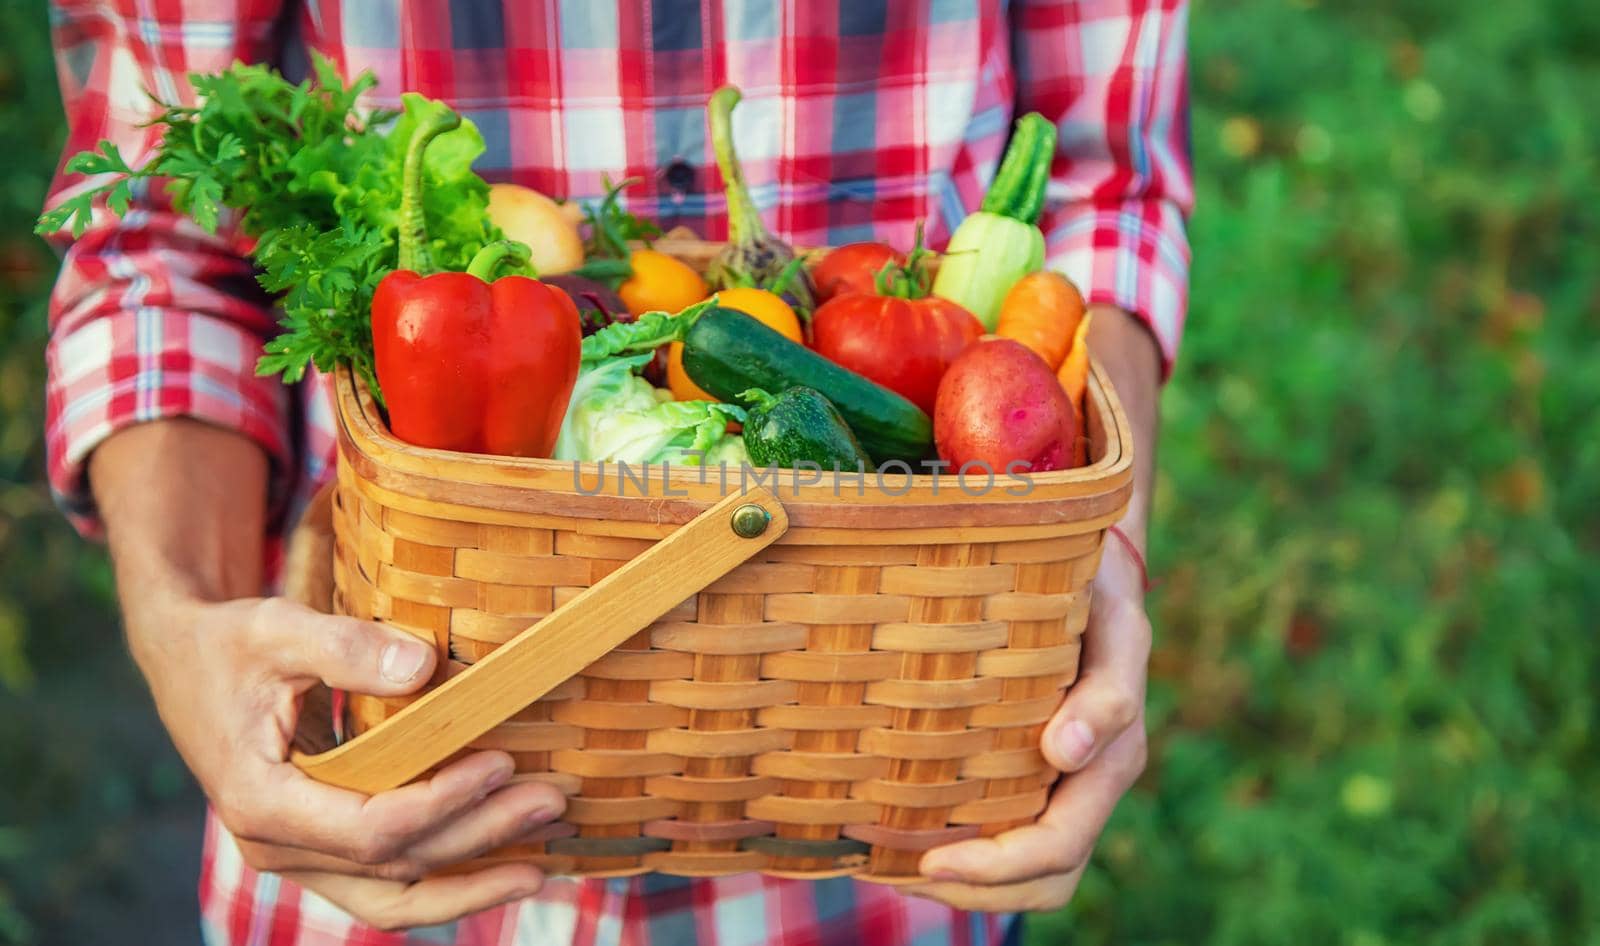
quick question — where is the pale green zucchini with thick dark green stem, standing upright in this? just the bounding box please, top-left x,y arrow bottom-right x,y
933,112 -> 1056,331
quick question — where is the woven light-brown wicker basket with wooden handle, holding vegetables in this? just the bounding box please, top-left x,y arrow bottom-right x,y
298,235 -> 1133,884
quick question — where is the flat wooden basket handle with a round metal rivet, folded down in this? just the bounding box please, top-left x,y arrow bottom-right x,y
291,487 -> 789,794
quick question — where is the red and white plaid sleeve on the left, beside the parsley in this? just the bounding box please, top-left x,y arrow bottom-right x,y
45,0 -> 293,535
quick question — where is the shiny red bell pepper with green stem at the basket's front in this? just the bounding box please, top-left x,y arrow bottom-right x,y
373,108 -> 582,456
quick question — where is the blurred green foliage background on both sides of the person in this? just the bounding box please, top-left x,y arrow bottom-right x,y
0,0 -> 1600,946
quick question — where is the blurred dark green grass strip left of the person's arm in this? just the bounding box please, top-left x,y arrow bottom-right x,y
0,9 -> 202,946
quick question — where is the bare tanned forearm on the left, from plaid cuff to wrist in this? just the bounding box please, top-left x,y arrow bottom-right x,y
90,418 -> 267,643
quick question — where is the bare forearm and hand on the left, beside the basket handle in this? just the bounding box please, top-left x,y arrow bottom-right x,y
91,421 -> 565,928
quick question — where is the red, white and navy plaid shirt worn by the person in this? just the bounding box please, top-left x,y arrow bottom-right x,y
46,0 -> 1192,946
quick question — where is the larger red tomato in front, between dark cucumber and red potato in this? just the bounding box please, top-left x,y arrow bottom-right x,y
811,293 -> 984,416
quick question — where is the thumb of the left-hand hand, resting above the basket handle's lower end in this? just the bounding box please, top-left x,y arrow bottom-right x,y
259,599 -> 438,696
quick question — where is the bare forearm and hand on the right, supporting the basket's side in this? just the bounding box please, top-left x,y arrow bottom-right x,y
906,306 -> 1160,912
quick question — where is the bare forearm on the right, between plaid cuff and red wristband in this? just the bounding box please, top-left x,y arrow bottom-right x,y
1090,306 -> 1162,551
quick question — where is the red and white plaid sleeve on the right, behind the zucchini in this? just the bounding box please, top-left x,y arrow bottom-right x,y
1011,0 -> 1194,376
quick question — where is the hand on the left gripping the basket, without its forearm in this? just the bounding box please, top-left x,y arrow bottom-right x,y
139,599 -> 565,890
